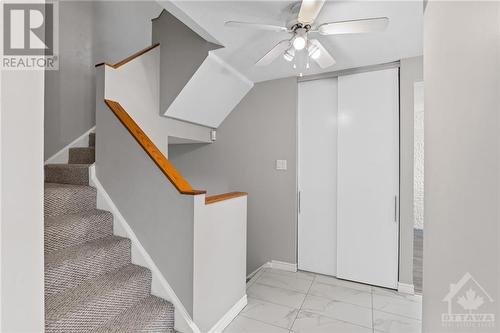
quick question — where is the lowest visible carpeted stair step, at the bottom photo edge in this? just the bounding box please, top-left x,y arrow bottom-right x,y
94,296 -> 174,333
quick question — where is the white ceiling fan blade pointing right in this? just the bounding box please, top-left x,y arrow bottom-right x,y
318,17 -> 389,35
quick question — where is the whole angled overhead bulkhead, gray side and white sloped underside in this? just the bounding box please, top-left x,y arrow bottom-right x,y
153,10 -> 253,128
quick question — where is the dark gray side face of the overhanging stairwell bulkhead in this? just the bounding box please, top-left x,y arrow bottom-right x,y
152,10 -> 221,114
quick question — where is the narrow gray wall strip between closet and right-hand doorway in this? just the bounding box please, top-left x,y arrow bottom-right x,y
399,57 -> 424,284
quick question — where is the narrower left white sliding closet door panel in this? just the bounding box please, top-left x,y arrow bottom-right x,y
298,78 -> 338,275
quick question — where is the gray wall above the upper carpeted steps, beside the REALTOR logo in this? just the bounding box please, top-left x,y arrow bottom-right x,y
44,1 -> 95,159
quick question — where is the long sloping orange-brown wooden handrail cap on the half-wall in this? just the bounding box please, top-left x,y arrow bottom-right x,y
104,99 -> 206,195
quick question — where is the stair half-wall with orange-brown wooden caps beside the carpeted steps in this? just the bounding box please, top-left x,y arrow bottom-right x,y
95,47 -> 247,332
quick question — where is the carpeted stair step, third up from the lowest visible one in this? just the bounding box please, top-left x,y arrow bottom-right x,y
45,236 -> 131,296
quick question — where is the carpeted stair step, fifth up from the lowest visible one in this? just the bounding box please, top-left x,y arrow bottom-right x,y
44,183 -> 97,216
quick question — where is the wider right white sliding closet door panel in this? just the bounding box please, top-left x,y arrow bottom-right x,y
337,69 -> 399,288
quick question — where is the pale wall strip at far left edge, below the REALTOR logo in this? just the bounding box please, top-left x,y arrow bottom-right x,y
0,68 -> 44,332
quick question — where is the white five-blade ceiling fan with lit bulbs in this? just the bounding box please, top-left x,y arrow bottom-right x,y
225,0 -> 389,68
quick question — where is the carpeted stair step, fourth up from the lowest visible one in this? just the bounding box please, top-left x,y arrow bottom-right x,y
44,209 -> 113,253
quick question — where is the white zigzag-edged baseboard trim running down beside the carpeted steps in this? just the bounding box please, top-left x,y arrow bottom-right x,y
89,165 -> 201,333
